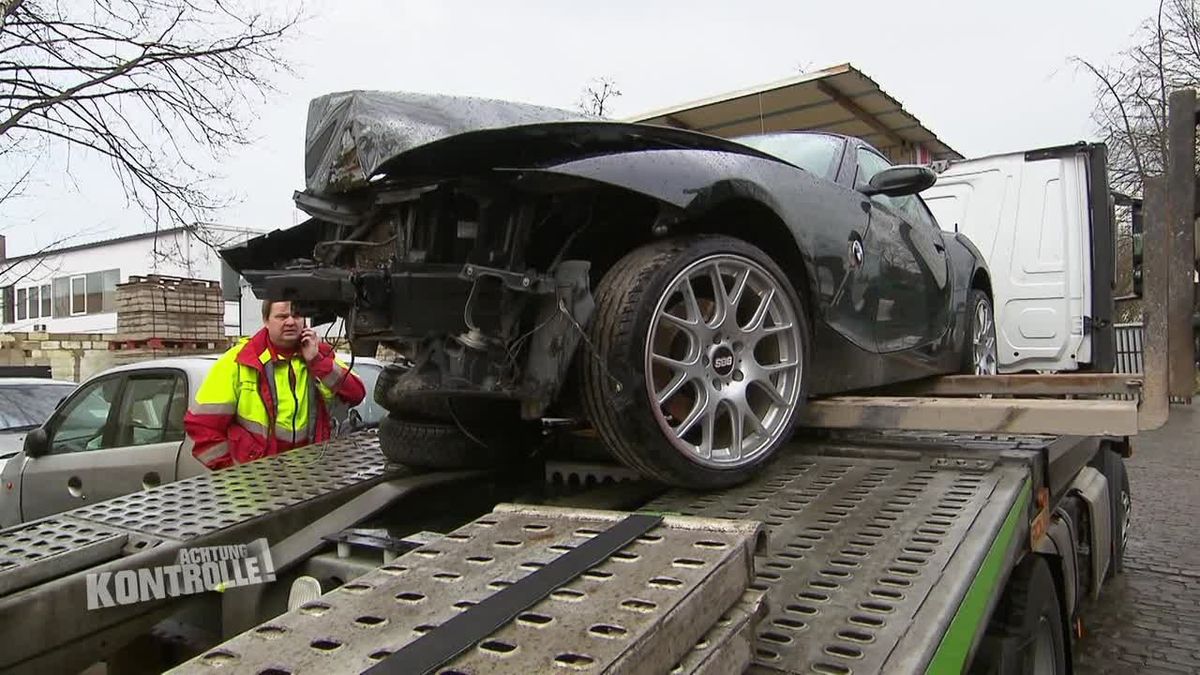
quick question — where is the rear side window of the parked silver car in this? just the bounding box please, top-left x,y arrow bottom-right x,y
114,372 -> 186,447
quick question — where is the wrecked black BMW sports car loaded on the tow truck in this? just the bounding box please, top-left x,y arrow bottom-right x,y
223,91 -> 996,488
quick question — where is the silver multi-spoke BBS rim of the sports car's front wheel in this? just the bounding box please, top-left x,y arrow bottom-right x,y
646,255 -> 804,468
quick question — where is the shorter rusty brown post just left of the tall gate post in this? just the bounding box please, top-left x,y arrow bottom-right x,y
1139,171 -> 1170,430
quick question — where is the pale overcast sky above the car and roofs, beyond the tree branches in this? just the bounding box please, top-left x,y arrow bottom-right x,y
0,0 -> 1157,255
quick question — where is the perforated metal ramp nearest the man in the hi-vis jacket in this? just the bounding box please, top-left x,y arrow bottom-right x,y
0,432 -> 396,673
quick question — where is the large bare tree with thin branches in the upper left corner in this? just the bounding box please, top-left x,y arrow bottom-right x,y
0,0 -> 300,247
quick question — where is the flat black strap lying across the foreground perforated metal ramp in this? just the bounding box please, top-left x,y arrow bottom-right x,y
366,514 -> 662,675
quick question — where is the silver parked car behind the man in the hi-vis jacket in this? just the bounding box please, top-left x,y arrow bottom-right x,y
0,354 -> 383,527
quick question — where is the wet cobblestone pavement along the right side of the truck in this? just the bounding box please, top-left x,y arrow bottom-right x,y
1076,402 -> 1200,675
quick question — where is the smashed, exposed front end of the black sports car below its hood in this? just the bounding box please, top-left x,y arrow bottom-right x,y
244,261 -> 594,419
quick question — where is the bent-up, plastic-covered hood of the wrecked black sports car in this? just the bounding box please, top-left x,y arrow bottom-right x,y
295,90 -> 774,196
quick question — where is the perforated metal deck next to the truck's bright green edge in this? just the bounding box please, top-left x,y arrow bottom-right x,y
646,447 -> 1026,675
